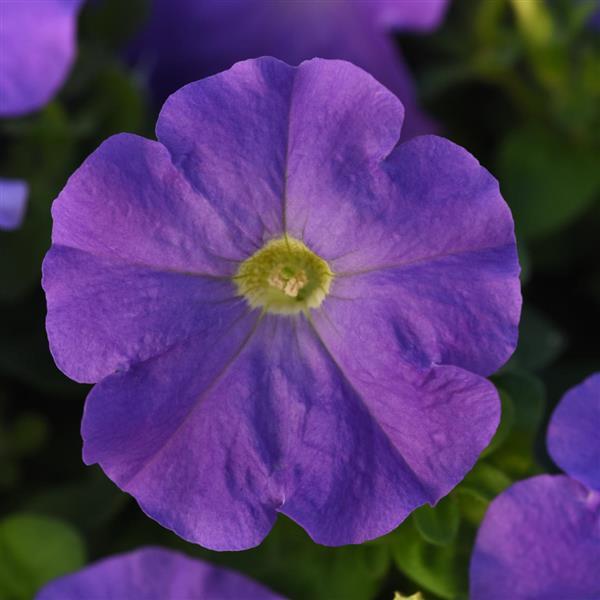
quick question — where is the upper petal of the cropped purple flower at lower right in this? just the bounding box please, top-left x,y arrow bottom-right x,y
547,373 -> 600,490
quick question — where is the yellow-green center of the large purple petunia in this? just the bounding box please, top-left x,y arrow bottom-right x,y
235,236 -> 333,315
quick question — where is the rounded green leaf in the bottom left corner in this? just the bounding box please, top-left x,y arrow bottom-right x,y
0,513 -> 85,600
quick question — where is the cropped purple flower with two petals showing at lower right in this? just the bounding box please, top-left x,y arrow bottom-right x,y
470,373 -> 600,600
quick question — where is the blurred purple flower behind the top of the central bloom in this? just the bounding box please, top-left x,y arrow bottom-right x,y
133,0 -> 448,138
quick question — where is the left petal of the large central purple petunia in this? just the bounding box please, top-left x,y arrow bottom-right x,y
43,134 -> 255,382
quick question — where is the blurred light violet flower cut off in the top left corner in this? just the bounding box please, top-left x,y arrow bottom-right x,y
0,0 -> 83,117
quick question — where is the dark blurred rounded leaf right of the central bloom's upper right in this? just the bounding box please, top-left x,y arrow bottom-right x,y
498,128 -> 600,239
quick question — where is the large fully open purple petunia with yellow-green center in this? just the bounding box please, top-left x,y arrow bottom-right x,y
43,58 -> 521,549
